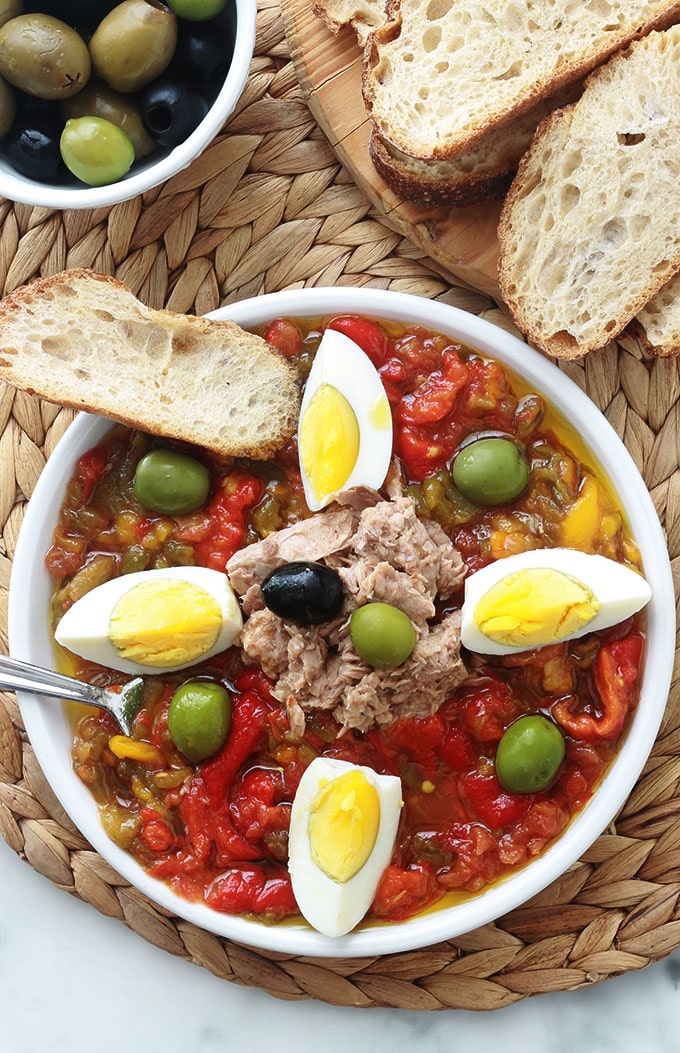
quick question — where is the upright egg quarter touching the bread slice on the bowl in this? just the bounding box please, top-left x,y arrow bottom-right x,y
298,329 -> 393,512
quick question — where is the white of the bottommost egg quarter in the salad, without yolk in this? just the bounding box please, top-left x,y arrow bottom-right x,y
288,757 -> 402,936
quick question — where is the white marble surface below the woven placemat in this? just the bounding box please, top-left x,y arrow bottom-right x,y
0,840 -> 680,1053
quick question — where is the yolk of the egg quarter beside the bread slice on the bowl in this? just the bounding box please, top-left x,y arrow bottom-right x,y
300,384 -> 359,500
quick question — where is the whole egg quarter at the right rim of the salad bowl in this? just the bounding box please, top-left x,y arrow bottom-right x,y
461,549 -> 652,655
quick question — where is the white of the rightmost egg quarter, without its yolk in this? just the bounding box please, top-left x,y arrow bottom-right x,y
461,549 -> 652,655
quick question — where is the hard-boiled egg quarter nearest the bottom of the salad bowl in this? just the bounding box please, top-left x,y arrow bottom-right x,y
288,757 -> 401,936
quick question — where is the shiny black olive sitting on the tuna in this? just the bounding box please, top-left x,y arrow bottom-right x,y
262,561 -> 344,625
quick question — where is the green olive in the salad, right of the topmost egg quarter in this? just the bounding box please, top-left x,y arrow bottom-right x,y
452,437 -> 528,505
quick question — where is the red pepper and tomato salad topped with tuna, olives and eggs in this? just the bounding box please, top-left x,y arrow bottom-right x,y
46,316 -> 644,931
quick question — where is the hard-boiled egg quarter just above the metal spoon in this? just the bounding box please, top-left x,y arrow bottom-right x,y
55,567 -> 243,675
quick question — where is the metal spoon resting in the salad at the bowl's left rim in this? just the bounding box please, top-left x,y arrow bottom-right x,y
0,655 -> 144,735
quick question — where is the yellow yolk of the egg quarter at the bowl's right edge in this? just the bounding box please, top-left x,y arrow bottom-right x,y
474,568 -> 600,648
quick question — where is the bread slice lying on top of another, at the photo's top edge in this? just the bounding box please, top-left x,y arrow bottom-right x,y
363,0 -> 680,160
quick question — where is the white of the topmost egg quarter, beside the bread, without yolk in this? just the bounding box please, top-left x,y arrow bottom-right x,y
298,329 -> 393,512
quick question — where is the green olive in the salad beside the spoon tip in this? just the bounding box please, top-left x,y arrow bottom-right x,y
167,680 -> 232,764
